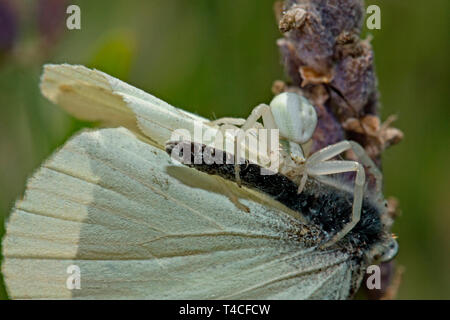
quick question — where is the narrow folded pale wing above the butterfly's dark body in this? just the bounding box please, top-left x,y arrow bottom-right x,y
41,64 -> 269,163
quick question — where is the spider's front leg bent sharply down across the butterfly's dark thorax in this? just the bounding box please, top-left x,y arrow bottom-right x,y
306,160 -> 365,247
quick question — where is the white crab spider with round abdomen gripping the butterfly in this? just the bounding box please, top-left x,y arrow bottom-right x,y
212,92 -> 383,246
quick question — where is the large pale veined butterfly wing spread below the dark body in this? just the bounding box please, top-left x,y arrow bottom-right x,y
2,128 -> 353,299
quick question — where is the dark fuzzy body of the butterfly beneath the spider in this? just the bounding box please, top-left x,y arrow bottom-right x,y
166,142 -> 387,254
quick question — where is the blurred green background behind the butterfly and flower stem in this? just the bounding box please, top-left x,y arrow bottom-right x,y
0,0 -> 450,299
